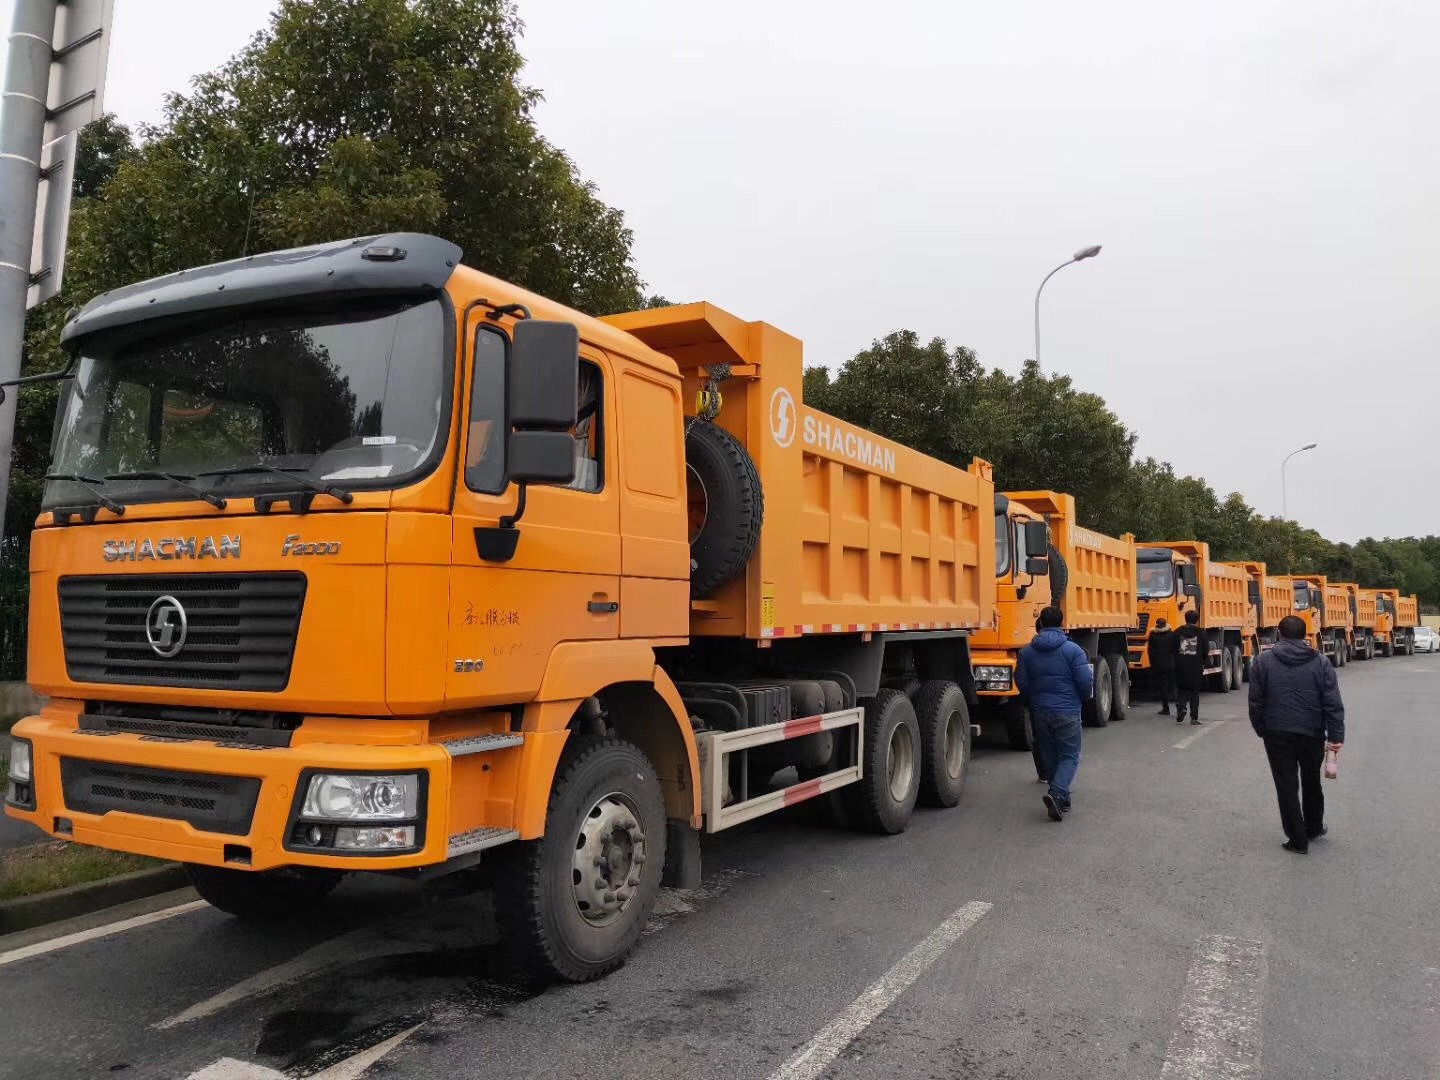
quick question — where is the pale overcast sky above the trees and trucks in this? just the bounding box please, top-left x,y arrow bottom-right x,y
0,0 -> 1440,540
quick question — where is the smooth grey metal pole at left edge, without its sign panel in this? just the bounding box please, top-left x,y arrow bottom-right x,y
0,0 -> 58,530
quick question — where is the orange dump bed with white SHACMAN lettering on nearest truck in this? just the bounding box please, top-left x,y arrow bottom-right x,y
606,304 -> 995,639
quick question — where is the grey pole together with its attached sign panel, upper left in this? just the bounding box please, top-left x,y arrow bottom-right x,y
0,0 -> 115,527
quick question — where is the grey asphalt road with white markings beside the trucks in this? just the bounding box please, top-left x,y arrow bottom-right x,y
0,657 -> 1440,1080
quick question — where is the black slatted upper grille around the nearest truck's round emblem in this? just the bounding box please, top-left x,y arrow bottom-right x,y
60,573 -> 305,691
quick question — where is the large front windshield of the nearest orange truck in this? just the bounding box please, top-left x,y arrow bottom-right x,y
43,300 -> 448,508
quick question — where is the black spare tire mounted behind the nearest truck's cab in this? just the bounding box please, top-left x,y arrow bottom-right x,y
685,420 -> 765,599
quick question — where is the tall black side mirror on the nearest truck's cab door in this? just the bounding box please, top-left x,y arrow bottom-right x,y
505,318 -> 580,484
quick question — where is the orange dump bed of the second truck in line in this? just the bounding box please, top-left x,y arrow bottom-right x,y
1005,491 -> 1138,631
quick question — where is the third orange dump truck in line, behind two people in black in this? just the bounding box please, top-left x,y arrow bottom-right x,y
1129,540 -> 1250,693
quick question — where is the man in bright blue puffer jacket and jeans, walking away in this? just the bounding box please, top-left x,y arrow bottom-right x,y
1015,608 -> 1094,821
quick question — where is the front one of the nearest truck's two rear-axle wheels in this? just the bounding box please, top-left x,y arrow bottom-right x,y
841,690 -> 920,835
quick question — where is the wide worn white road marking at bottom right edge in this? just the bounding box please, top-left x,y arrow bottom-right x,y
1161,936 -> 1266,1080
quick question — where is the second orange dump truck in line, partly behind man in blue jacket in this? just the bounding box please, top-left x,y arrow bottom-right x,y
971,491 -> 1136,750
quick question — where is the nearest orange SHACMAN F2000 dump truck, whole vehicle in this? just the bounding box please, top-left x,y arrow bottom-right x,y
6,233 -> 995,981
